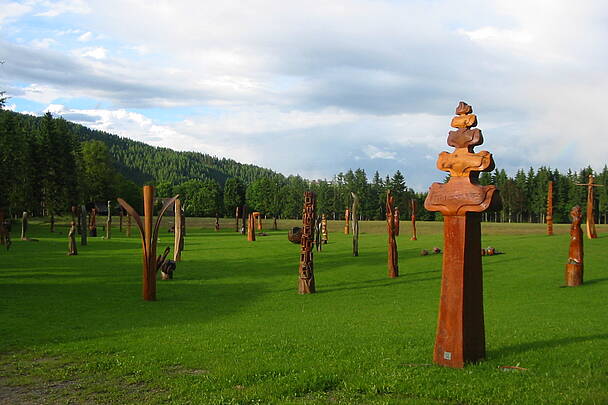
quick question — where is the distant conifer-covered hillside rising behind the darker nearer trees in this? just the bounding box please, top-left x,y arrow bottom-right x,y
0,111 -> 282,186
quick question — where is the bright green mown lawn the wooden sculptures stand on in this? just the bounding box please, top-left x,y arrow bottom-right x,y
0,219 -> 608,404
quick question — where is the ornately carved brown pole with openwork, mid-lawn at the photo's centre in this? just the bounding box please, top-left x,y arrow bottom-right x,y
298,191 -> 316,294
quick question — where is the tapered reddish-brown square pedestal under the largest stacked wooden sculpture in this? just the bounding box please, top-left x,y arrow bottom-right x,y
433,213 -> 485,368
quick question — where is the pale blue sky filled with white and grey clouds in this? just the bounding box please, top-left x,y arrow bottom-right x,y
0,0 -> 608,191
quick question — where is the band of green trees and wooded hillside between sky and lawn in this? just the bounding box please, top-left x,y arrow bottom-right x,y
0,110 -> 608,223
